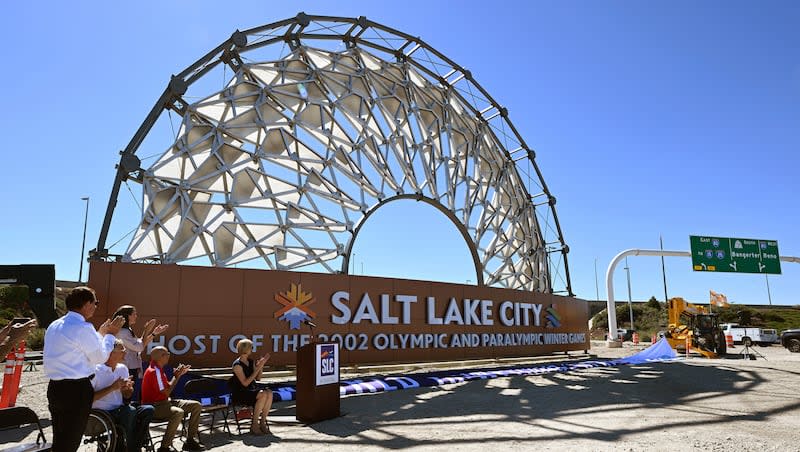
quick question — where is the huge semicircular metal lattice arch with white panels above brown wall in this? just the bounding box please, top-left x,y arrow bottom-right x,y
95,13 -> 572,295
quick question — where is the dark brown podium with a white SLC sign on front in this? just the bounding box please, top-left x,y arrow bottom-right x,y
295,342 -> 339,424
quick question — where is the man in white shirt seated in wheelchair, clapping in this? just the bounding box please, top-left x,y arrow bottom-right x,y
92,339 -> 153,452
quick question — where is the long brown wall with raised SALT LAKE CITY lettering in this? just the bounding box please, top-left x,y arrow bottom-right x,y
89,262 -> 590,367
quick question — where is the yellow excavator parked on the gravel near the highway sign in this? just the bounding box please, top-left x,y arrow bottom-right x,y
664,297 -> 727,358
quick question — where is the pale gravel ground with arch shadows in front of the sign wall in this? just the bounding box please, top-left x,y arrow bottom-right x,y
0,342 -> 800,452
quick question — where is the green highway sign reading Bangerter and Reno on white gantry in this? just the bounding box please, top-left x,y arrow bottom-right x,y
689,235 -> 781,275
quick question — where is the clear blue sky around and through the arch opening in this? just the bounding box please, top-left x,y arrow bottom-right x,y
0,0 -> 800,305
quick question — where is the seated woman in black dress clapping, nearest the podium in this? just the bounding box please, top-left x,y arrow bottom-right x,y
232,339 -> 272,435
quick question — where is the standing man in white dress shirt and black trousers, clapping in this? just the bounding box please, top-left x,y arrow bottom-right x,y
43,287 -> 125,452
